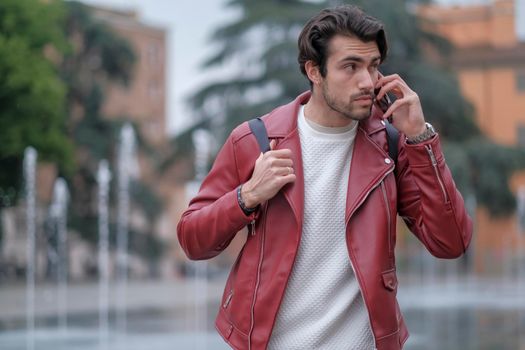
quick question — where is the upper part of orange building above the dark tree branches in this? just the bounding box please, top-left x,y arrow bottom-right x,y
420,0 -> 525,146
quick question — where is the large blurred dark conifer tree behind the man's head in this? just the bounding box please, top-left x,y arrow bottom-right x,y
188,0 -> 525,215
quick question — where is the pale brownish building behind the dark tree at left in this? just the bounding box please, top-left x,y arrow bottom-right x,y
92,7 -> 168,146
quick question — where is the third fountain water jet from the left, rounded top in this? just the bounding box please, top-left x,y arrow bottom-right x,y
97,160 -> 111,349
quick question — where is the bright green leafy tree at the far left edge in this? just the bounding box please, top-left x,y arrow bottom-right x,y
0,0 -> 73,207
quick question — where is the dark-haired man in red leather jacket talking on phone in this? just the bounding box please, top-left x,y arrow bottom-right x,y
177,6 -> 472,350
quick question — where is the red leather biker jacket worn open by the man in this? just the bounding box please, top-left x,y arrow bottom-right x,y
177,92 -> 472,350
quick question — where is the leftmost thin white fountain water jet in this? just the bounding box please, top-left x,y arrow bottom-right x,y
24,147 -> 37,350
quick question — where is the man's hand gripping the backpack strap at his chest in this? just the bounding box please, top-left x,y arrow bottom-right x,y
241,140 -> 295,208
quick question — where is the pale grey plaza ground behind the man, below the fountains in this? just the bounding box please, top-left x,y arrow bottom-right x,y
0,276 -> 525,350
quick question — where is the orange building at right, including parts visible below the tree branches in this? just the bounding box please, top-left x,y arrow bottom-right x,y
418,0 -> 525,273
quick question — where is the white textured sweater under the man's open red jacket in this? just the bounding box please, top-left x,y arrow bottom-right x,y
268,107 -> 375,350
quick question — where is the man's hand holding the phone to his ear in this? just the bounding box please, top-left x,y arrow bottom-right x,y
375,74 -> 426,137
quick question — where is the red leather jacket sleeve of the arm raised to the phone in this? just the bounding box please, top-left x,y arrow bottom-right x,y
397,135 -> 472,259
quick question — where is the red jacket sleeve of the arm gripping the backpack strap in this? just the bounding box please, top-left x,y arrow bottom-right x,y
177,131 -> 256,260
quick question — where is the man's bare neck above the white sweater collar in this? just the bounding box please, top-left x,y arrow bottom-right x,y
304,91 -> 357,128
